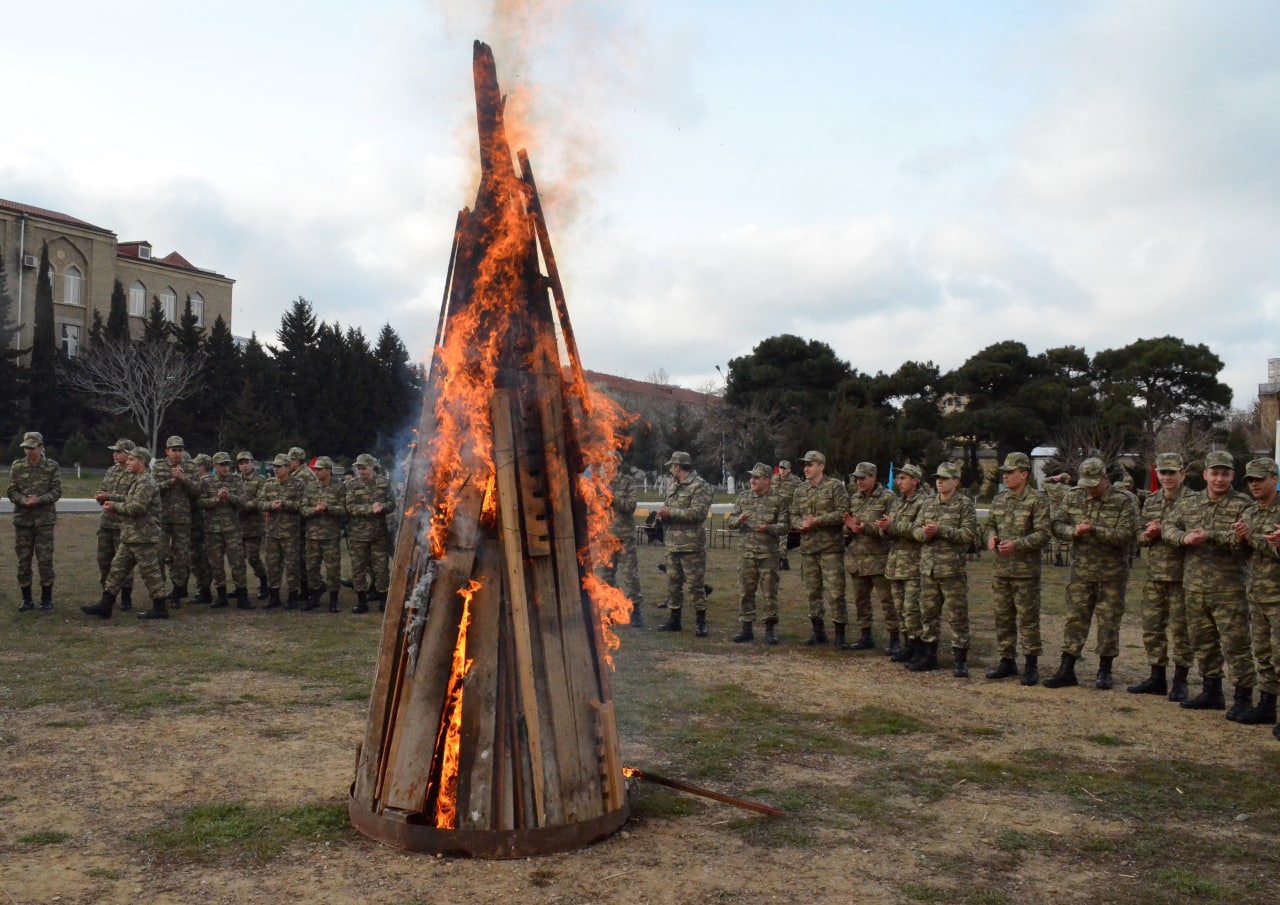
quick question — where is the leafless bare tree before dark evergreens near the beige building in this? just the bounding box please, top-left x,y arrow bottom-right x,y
63,342 -> 205,453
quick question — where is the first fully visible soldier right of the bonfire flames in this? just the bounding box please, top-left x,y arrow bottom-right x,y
658,451 -> 712,637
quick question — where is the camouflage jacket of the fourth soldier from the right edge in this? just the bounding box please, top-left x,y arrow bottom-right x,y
1053,486 -> 1138,581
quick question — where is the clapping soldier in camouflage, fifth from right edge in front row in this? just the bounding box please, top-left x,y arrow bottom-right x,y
984,453 -> 1050,685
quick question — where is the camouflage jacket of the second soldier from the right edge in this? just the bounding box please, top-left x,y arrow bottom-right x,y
1161,490 -> 1252,594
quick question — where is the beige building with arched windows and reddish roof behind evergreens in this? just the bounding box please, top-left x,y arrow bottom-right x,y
0,198 -> 236,357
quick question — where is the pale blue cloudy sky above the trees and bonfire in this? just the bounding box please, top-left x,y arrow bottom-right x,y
0,0 -> 1280,407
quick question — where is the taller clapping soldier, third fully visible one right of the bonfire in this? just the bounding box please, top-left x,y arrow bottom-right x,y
791,449 -> 849,650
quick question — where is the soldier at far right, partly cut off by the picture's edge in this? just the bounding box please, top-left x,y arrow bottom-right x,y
1235,458 -> 1280,739
